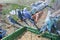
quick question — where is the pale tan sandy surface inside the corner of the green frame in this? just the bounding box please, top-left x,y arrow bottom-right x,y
18,31 -> 50,40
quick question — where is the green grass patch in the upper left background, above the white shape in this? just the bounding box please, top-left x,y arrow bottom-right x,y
2,4 -> 30,15
